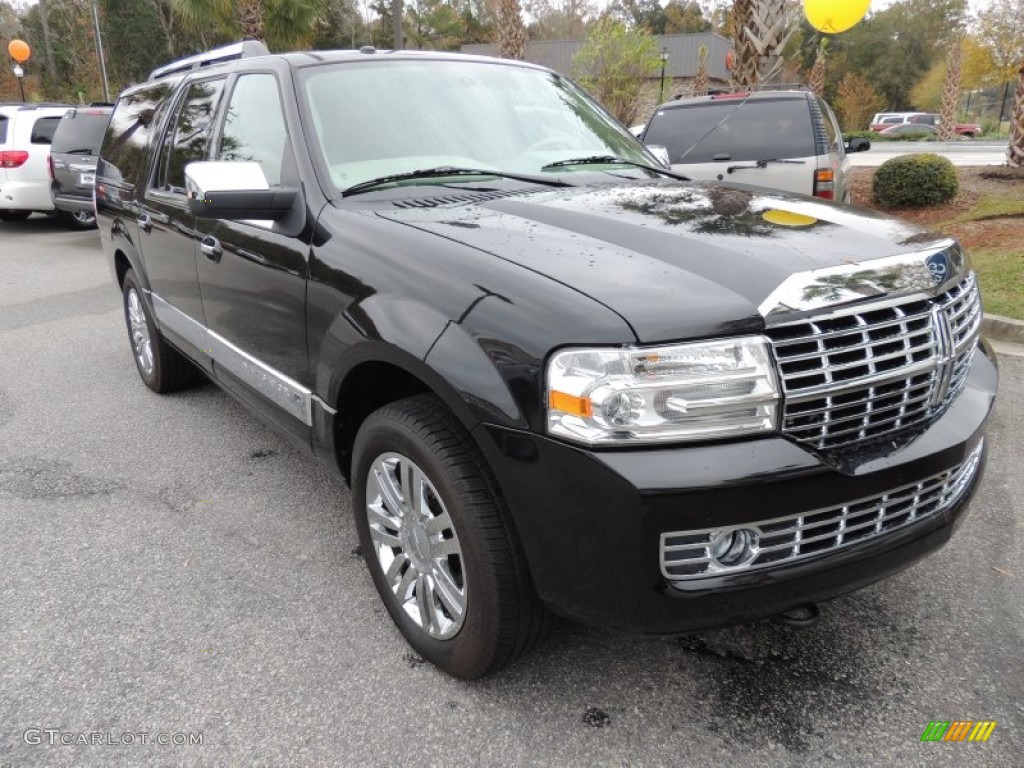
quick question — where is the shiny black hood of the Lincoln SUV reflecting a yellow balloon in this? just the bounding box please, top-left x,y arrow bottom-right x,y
375,180 -> 948,342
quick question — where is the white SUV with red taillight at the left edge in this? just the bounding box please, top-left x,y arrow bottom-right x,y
0,103 -> 70,221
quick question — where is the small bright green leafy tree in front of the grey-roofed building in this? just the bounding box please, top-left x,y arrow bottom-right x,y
572,16 -> 662,125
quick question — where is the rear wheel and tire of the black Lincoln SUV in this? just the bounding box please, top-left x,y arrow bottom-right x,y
123,269 -> 203,394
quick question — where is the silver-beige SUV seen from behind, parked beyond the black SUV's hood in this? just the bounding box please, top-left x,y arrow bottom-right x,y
642,90 -> 871,202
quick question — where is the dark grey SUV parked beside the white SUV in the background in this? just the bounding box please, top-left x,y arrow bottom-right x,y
49,104 -> 114,229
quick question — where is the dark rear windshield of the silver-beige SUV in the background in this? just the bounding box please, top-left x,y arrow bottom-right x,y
643,98 -> 815,163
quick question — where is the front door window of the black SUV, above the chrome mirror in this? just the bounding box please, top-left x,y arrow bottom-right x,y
215,74 -> 288,186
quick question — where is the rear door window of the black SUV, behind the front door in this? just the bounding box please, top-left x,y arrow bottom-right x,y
157,78 -> 224,195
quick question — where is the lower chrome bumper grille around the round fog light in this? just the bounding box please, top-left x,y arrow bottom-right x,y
659,442 -> 983,581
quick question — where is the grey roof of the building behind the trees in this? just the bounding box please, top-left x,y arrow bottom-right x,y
462,32 -> 732,81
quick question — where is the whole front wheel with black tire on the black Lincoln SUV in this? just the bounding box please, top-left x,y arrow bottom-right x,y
352,396 -> 550,679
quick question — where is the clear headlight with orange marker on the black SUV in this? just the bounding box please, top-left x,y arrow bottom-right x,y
548,336 -> 779,444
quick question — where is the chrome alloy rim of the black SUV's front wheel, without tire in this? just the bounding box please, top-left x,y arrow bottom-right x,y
367,453 -> 466,640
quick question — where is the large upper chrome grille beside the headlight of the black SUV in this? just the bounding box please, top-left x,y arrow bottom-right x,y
766,272 -> 981,450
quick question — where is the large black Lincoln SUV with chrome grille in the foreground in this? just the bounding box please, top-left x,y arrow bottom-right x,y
96,43 -> 997,678
